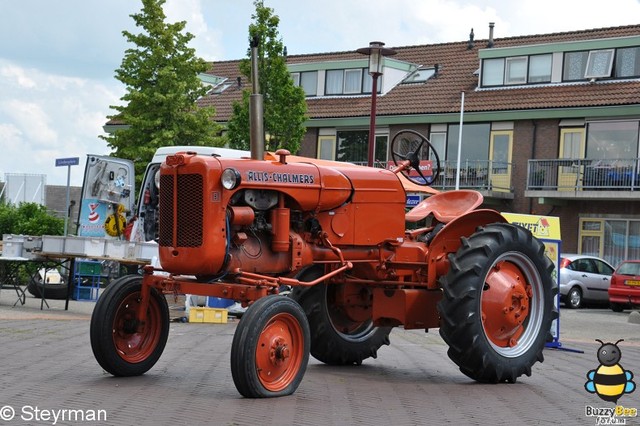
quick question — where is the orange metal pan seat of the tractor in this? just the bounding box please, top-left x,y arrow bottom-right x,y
405,189 -> 484,223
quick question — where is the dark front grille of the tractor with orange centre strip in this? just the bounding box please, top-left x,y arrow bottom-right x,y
158,174 -> 203,247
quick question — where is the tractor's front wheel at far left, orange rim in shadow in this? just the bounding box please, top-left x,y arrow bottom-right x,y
90,275 -> 169,376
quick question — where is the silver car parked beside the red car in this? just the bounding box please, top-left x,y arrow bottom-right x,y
560,254 -> 614,309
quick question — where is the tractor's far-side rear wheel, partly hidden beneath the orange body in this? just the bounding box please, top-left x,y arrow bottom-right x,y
289,266 -> 391,365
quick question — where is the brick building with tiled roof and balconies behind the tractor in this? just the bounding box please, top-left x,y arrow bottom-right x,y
106,25 -> 640,264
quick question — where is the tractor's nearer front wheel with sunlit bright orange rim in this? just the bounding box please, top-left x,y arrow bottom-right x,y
231,295 -> 309,398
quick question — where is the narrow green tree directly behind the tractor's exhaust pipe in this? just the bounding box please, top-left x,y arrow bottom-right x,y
227,0 -> 307,154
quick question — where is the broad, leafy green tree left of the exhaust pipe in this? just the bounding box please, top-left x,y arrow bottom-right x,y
101,0 -> 223,179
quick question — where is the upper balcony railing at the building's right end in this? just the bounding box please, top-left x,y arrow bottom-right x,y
527,158 -> 640,191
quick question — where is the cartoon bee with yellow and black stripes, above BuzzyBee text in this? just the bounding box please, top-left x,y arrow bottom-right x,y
584,339 -> 636,403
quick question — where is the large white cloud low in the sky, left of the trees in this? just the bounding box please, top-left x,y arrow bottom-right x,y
0,61 -> 120,185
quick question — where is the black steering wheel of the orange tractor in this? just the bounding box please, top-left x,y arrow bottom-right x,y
391,130 -> 440,186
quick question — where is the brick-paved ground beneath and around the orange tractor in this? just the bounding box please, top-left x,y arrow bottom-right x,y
0,290 -> 640,426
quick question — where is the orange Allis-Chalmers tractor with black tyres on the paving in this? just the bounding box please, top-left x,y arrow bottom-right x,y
90,130 -> 557,398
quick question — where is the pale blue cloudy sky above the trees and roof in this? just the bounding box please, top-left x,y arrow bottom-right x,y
0,0 -> 640,185
